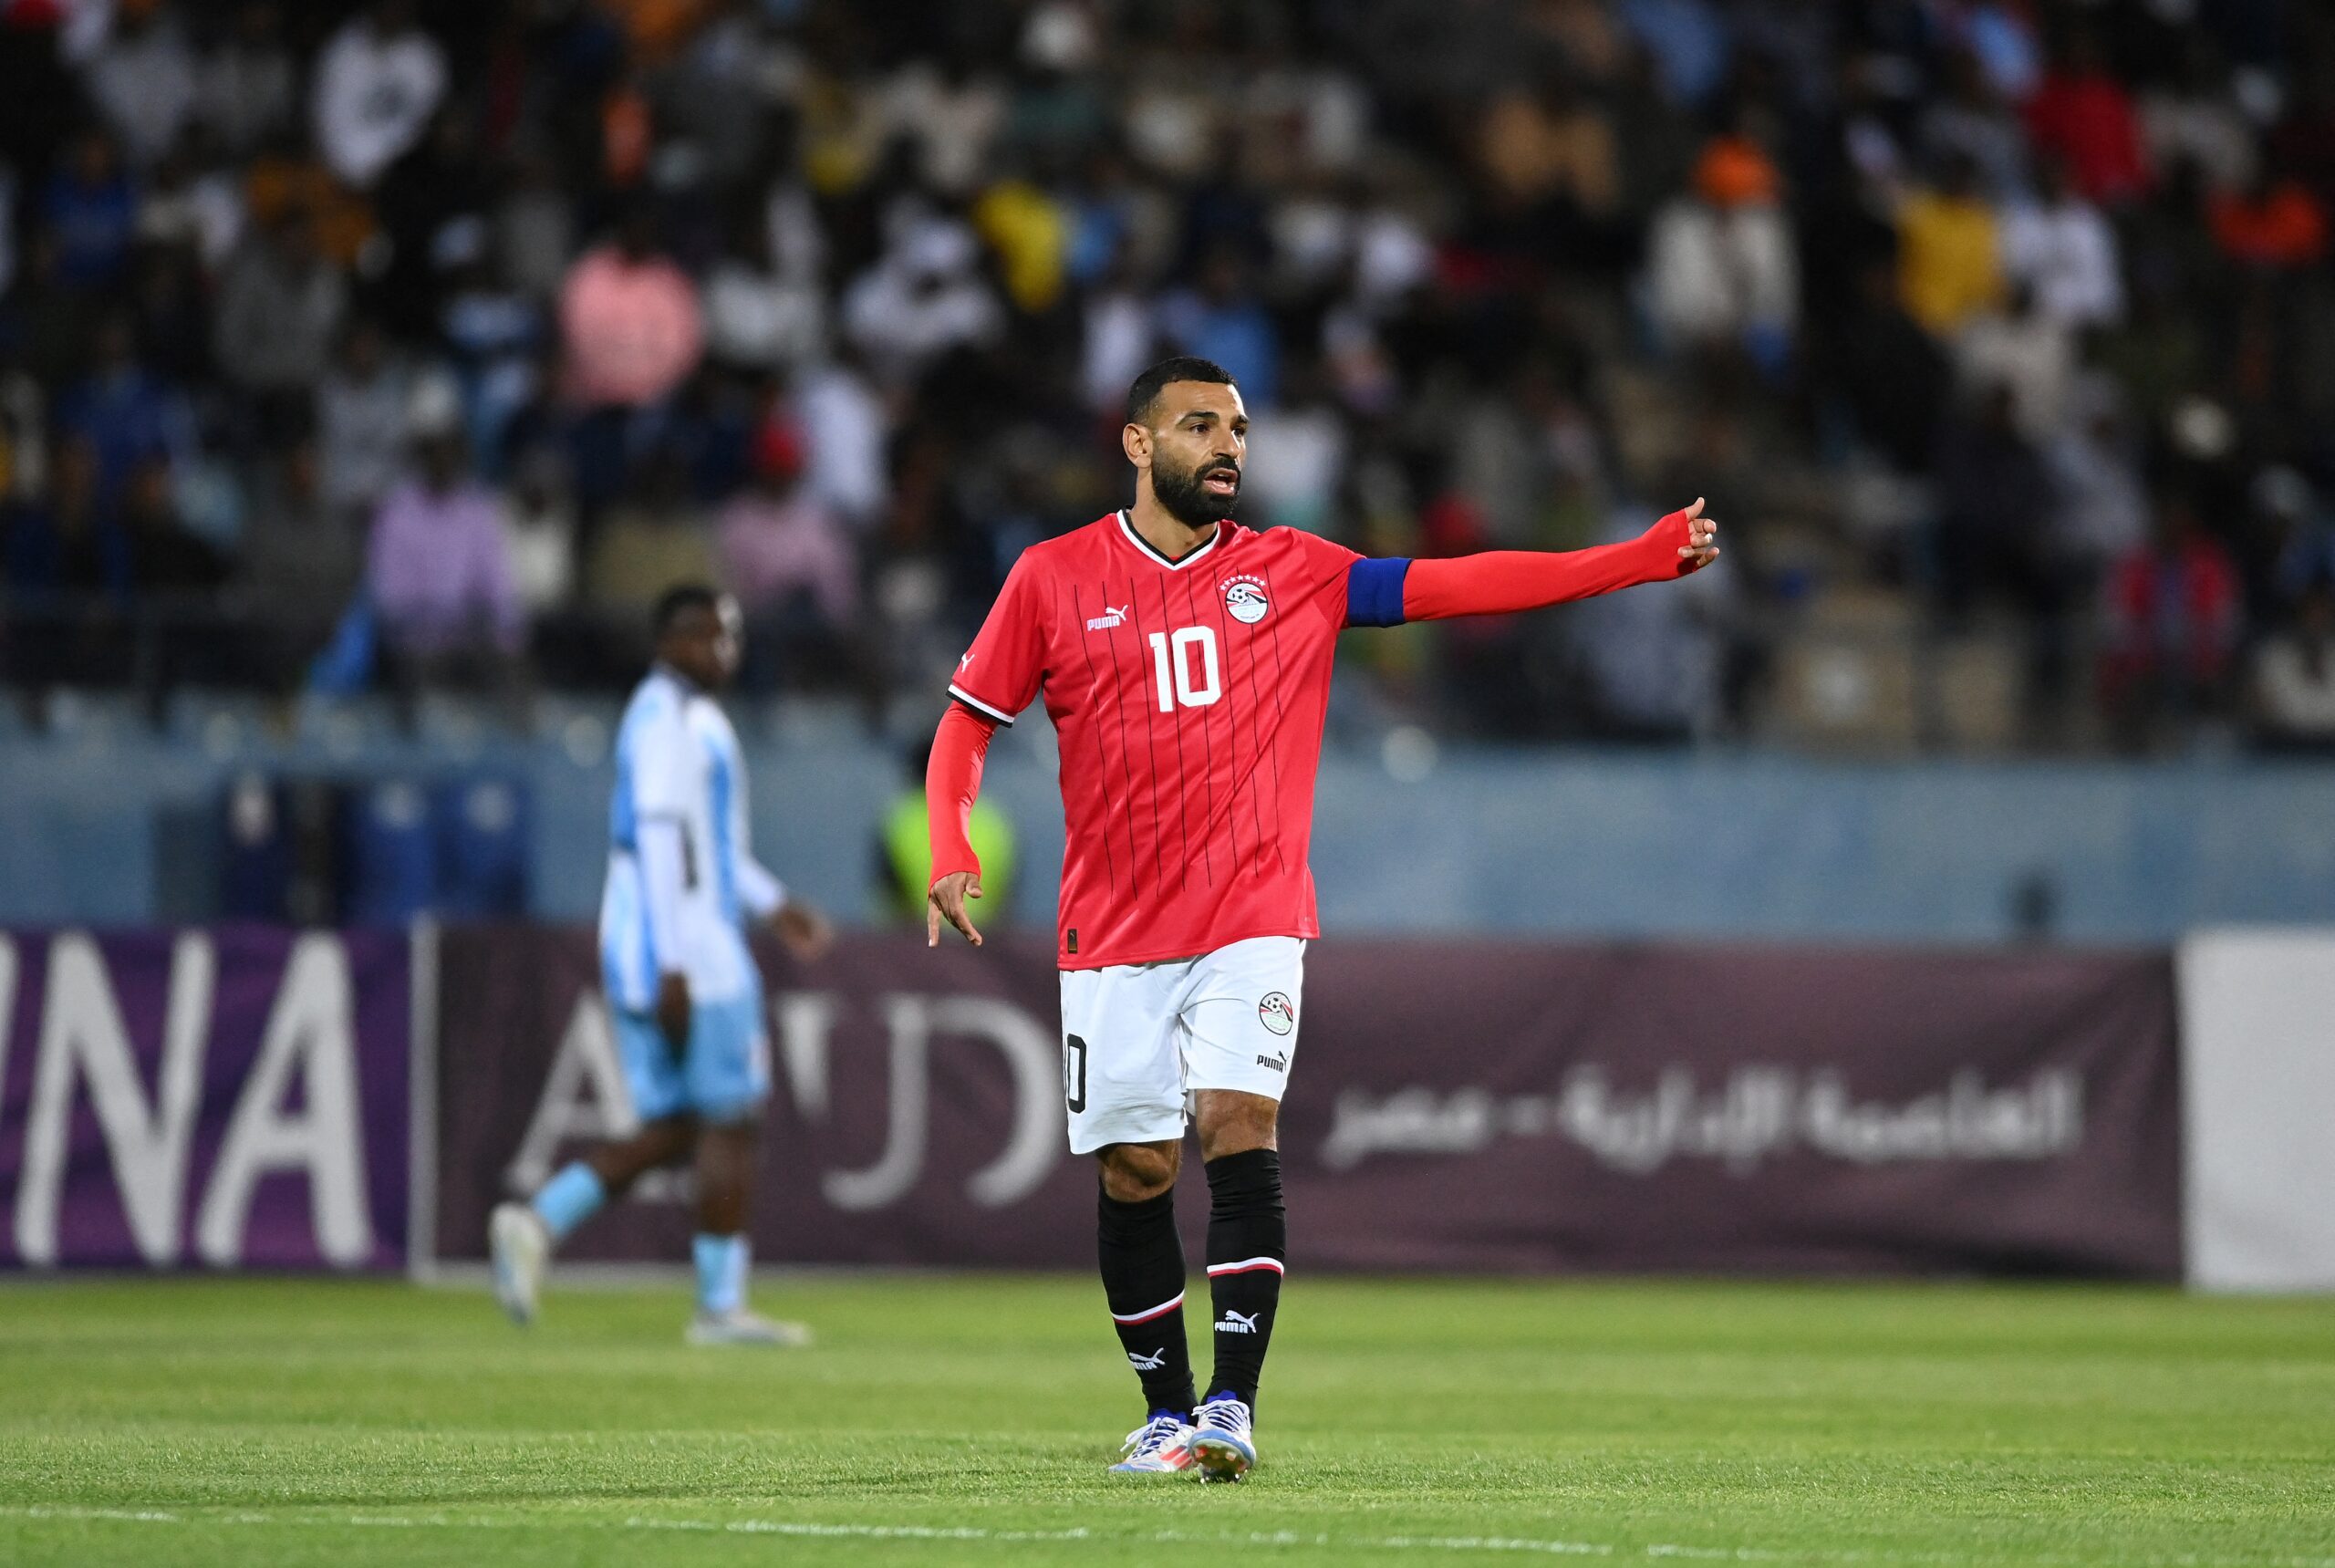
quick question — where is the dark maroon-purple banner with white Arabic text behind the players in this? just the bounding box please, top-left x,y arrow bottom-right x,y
434,928 -> 2181,1278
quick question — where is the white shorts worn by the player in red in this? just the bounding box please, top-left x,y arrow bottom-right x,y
1063,937 -> 1305,1155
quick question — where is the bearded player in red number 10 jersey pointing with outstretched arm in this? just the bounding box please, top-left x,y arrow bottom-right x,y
925,358 -> 1718,1480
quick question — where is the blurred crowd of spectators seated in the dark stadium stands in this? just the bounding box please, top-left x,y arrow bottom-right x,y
0,0 -> 2335,750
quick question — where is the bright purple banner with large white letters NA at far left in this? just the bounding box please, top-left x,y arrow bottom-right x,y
0,928 -> 411,1269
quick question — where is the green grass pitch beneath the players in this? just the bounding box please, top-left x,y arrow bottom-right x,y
0,1276 -> 2335,1568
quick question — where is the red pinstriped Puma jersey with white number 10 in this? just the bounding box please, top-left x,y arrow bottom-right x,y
948,512 -> 1364,970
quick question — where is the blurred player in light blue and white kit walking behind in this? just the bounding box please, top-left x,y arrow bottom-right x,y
488,587 -> 829,1344
